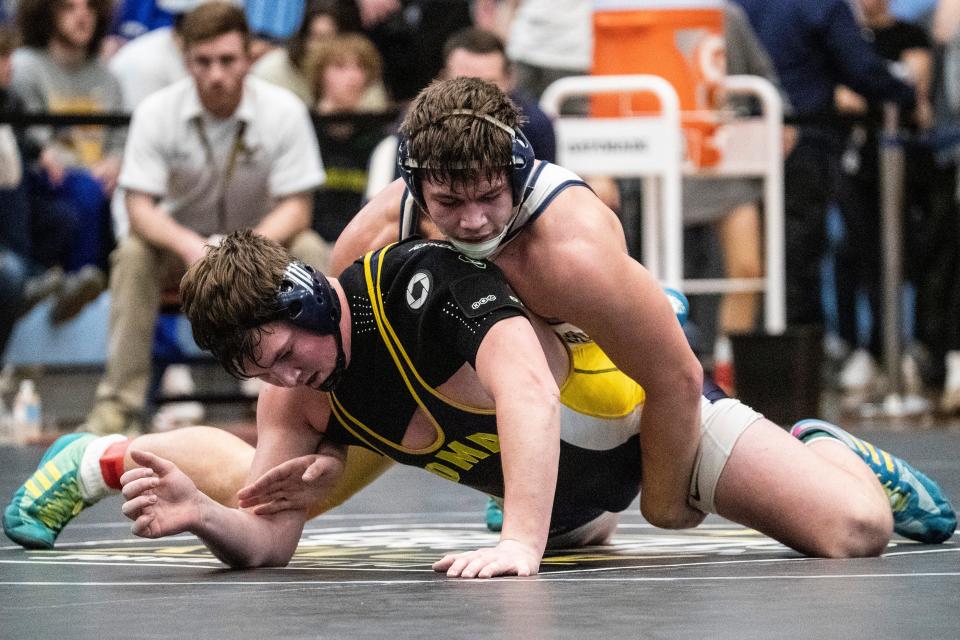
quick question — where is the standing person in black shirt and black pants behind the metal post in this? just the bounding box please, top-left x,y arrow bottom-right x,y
836,0 -> 932,401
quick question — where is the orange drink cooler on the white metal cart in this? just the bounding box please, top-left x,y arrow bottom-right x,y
591,0 -> 725,167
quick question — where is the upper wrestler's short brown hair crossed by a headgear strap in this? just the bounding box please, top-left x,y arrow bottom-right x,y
400,78 -> 523,188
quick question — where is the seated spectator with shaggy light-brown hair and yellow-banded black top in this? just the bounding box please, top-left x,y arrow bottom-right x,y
310,33 -> 384,249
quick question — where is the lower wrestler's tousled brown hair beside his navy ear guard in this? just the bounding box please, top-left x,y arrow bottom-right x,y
180,229 -> 293,378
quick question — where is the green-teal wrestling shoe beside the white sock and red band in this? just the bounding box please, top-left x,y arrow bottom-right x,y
3,433 -> 97,549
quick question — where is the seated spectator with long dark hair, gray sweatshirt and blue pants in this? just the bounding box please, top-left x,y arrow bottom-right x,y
12,0 -> 123,321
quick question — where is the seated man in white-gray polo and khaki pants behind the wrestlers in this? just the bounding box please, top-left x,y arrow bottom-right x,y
86,2 -> 327,434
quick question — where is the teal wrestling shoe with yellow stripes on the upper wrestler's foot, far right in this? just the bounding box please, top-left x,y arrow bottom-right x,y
790,420 -> 957,544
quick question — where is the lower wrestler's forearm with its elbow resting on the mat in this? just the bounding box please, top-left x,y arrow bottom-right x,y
190,494 -> 306,569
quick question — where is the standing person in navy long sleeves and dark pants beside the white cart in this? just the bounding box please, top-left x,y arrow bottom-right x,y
737,0 -> 916,326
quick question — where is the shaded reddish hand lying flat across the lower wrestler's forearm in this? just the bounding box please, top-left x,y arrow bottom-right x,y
237,454 -> 344,515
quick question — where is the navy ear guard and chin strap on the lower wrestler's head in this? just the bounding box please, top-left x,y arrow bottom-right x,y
277,260 -> 347,391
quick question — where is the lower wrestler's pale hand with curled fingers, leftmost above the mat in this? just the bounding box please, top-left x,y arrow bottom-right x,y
120,450 -> 202,538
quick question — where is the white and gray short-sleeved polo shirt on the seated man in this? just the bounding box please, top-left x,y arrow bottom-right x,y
120,76 -> 325,235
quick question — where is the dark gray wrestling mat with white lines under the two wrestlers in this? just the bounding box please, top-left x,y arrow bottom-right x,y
0,430 -> 960,640
